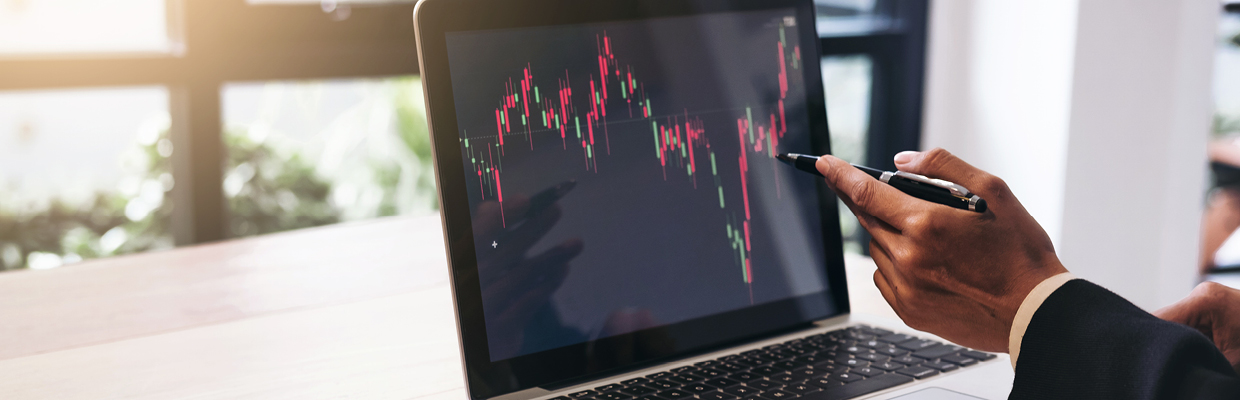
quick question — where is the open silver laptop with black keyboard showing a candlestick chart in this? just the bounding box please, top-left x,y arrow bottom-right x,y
414,0 -> 1013,400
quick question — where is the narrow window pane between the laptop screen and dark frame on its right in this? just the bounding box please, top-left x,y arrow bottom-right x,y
822,56 -> 874,254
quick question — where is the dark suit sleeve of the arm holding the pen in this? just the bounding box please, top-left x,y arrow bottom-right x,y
1011,280 -> 1240,400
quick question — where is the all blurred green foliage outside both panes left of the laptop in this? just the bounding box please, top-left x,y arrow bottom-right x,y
0,77 -> 438,270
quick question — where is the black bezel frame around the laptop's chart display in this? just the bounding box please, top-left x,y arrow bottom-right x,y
414,0 -> 849,399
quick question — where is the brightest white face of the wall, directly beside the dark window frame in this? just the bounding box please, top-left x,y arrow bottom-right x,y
923,0 -> 1076,250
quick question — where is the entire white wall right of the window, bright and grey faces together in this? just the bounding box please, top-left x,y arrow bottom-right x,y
923,0 -> 1219,310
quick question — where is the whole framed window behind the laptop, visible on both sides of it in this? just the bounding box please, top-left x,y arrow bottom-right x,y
0,0 -> 928,269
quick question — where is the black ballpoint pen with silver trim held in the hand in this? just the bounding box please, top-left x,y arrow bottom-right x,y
776,152 -> 986,213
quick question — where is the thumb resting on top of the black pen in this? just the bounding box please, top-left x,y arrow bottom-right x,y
895,147 -> 1012,201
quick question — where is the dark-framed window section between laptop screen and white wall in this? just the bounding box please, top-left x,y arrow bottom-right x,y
816,0 -> 929,254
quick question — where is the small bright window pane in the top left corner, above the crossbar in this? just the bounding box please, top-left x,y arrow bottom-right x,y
0,0 -> 171,56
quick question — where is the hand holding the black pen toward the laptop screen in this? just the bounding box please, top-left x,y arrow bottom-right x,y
817,149 -> 1066,353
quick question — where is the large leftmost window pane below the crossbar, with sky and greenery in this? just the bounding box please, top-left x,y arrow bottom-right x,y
0,87 -> 174,270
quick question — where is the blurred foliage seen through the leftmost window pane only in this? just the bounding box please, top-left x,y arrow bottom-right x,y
0,130 -> 175,270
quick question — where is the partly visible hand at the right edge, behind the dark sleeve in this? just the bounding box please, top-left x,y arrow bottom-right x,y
1154,282 -> 1240,373
